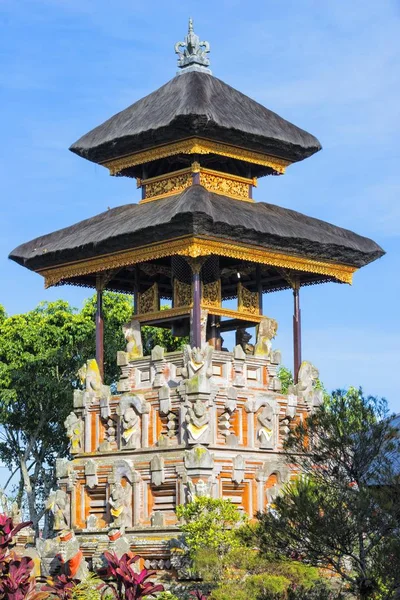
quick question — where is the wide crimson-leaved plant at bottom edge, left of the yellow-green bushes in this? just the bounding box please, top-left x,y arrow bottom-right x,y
99,552 -> 164,600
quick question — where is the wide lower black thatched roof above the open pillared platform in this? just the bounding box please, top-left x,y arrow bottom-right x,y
10,185 -> 384,270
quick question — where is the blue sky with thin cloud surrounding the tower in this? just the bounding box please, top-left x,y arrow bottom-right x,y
0,0 -> 400,411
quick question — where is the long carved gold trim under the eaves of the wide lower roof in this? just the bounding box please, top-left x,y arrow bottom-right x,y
38,236 -> 357,288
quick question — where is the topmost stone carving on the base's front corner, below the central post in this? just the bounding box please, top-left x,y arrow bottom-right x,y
182,344 -> 213,394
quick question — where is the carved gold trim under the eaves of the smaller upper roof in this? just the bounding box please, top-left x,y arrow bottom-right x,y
102,138 -> 291,175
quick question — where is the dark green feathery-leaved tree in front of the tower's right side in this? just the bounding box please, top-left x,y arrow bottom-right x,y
257,389 -> 400,600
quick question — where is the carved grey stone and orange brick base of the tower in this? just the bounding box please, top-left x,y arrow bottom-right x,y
47,345 -> 319,571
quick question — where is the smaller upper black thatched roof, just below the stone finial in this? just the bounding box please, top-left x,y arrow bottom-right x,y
70,72 -> 321,163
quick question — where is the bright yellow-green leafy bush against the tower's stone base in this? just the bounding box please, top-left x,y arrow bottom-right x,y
176,497 -> 245,556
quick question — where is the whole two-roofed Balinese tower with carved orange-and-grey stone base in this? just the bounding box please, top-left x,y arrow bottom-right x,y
10,21 -> 383,571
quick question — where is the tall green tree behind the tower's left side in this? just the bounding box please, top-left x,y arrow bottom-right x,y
0,292 -> 182,532
